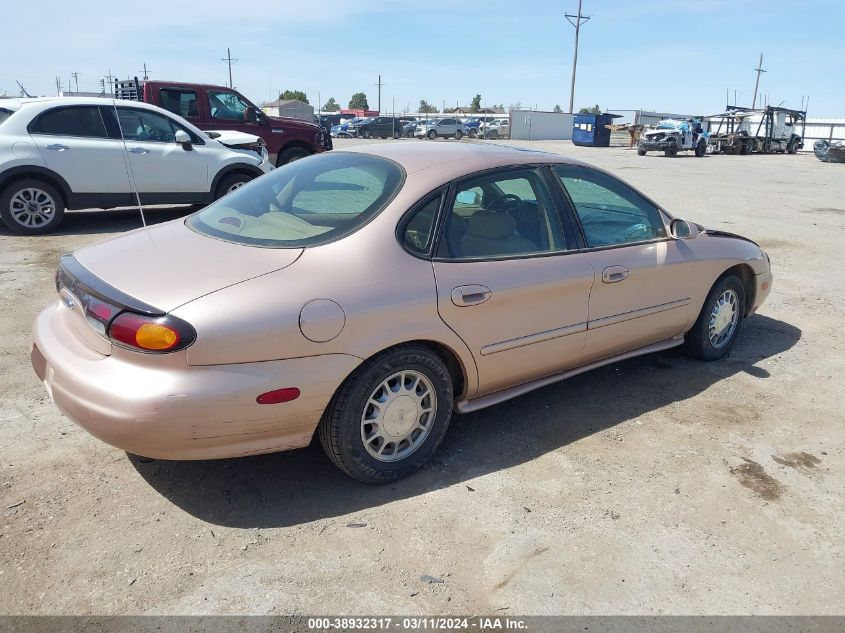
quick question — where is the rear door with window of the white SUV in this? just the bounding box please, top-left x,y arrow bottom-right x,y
29,105 -> 131,195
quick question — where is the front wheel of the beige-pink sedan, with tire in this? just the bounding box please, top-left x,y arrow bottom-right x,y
684,275 -> 745,361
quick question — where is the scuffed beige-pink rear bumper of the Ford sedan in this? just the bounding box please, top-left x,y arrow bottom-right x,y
30,304 -> 361,459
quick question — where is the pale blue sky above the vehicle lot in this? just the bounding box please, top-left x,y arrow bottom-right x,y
6,0 -> 845,117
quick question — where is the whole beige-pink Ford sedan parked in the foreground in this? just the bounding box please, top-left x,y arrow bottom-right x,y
31,143 -> 772,482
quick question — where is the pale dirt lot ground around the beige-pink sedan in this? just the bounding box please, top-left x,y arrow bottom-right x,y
0,140 -> 845,614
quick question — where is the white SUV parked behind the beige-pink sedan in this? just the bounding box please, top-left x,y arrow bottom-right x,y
0,97 -> 273,234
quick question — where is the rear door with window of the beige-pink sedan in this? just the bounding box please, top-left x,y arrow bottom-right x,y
433,168 -> 594,395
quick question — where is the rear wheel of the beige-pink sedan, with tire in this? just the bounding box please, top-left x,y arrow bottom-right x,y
317,345 -> 453,483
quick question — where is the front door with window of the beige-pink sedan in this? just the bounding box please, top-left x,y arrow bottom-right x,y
553,165 -> 697,363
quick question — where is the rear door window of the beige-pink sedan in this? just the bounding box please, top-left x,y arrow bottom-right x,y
443,169 -> 566,259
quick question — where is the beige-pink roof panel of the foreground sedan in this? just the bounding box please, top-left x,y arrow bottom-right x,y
334,141 -> 584,174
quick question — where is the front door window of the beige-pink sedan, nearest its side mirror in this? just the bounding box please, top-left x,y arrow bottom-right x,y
554,165 -> 666,248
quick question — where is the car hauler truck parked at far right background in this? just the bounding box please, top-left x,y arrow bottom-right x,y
707,106 -> 807,154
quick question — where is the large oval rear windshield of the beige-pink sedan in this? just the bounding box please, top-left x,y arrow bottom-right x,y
187,152 -> 405,248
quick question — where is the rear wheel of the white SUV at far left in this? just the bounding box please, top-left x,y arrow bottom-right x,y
0,178 -> 65,235
